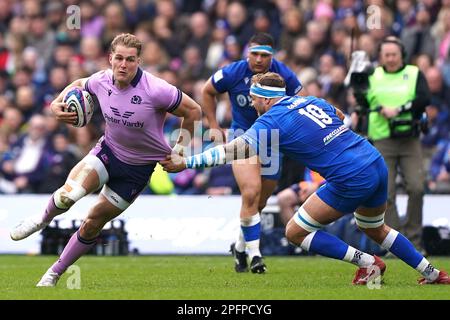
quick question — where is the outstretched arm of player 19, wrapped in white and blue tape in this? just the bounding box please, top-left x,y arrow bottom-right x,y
160,137 -> 256,172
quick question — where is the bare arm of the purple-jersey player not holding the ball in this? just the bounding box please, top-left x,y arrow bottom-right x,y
172,93 -> 202,154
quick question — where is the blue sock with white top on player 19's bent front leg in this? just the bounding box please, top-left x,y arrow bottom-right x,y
301,230 -> 349,260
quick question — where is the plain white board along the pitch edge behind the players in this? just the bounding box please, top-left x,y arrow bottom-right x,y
0,195 -> 450,254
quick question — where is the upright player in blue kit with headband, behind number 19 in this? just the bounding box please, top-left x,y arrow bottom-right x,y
202,33 -> 302,273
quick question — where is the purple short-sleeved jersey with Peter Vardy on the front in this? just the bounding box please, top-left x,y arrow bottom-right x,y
85,68 -> 182,165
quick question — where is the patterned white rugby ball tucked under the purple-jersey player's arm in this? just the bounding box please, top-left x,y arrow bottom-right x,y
63,88 -> 95,128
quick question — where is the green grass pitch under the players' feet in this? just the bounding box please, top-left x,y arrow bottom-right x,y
0,255 -> 450,300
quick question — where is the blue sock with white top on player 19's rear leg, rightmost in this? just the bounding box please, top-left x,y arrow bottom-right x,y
381,229 -> 423,269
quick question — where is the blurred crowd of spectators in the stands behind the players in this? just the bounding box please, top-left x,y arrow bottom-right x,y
0,0 -> 450,194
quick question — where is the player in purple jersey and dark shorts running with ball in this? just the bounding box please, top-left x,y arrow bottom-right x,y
11,34 -> 201,287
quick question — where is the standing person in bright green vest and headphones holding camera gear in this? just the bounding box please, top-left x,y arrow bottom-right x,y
354,36 -> 430,252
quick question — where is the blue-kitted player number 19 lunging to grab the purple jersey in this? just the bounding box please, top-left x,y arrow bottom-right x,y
161,73 -> 450,285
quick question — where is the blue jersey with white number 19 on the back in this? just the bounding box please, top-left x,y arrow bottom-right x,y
242,96 -> 381,182
